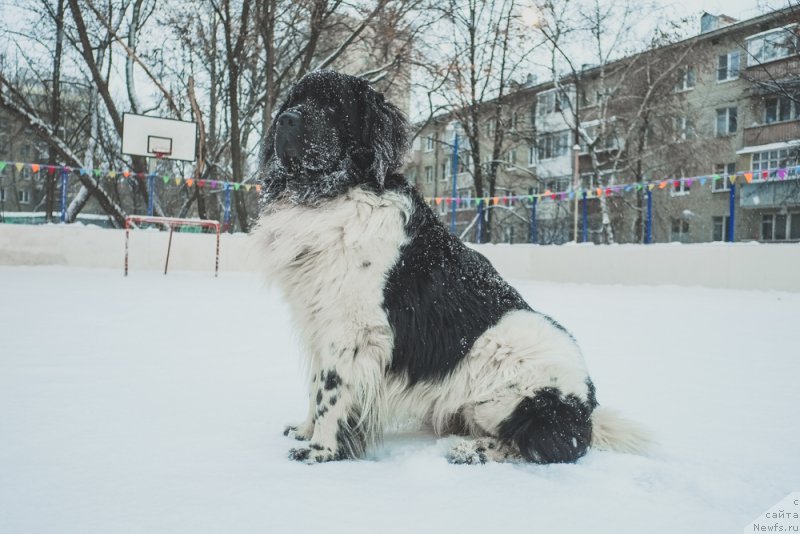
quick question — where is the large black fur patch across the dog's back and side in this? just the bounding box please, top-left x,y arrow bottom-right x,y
384,184 -> 530,385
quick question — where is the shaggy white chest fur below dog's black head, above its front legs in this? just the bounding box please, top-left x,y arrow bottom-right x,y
255,188 -> 411,369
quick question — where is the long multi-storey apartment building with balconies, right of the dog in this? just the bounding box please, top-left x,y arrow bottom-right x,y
407,8 -> 800,244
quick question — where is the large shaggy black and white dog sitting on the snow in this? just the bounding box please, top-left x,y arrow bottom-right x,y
255,71 -> 644,463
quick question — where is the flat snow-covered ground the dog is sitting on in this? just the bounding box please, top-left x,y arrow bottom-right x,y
0,267 -> 800,533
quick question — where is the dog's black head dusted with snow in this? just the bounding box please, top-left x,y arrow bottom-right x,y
262,71 -> 408,204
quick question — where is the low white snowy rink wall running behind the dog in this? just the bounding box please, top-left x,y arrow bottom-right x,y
0,225 -> 800,291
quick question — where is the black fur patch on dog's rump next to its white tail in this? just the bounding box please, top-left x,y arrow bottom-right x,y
497,384 -> 596,464
